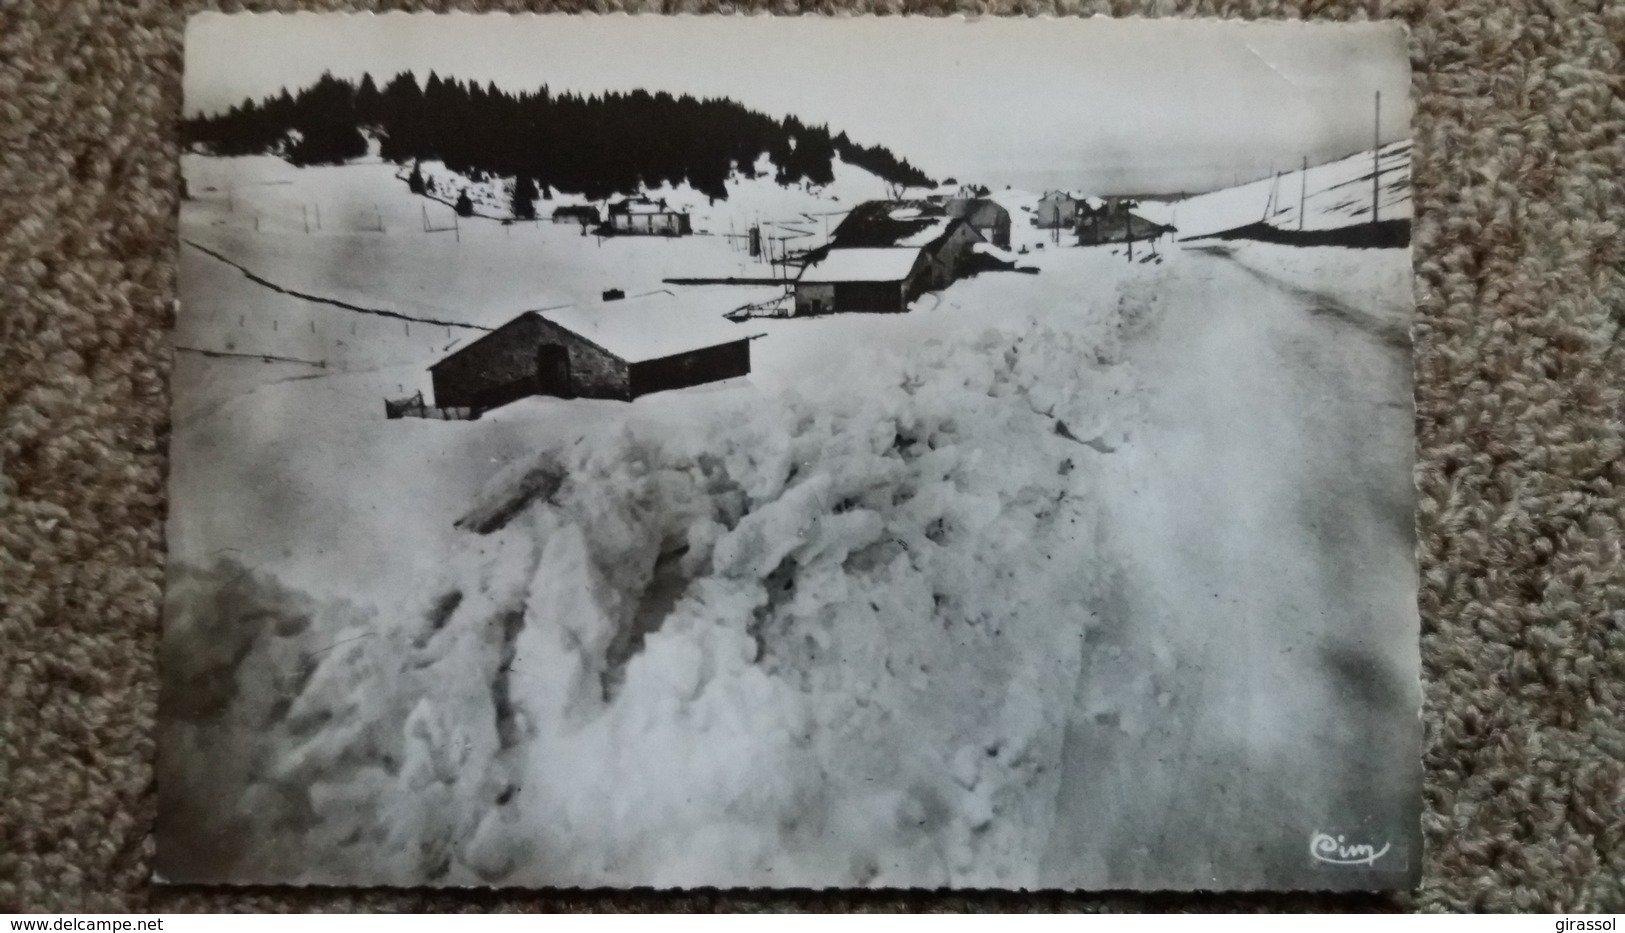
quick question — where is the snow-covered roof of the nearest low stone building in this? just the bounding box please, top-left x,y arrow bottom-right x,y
533,289 -> 761,362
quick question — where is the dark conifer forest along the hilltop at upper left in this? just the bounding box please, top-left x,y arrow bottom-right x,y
182,72 -> 933,198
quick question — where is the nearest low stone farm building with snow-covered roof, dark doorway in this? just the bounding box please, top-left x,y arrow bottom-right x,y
429,291 -> 757,413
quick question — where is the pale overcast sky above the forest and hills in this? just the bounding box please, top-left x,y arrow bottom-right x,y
185,13 -> 1411,193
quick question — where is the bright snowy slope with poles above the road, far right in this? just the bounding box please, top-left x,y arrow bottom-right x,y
1152,140 -> 1411,239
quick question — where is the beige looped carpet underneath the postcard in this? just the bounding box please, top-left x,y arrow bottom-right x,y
0,0 -> 1625,910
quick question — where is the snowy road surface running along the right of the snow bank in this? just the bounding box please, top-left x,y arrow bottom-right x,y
1043,247 -> 1420,889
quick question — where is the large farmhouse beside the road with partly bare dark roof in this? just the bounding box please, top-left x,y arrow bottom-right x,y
795,202 -> 985,315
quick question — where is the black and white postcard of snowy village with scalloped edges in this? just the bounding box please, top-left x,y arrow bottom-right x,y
156,13 -> 1422,891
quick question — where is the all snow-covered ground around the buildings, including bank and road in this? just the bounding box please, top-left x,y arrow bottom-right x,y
161,156 -> 1417,887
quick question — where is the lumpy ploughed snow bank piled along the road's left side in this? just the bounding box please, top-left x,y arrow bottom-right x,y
166,314 -> 1116,886
